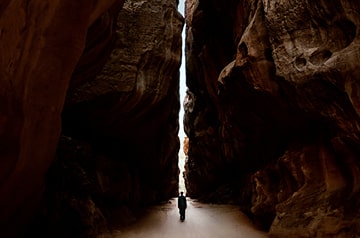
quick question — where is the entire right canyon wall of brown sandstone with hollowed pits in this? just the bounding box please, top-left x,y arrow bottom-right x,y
184,0 -> 360,237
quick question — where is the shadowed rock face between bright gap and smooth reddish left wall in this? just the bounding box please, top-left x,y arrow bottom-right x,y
62,0 -> 183,234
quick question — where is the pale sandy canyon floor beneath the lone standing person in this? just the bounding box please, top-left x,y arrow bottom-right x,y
114,198 -> 268,238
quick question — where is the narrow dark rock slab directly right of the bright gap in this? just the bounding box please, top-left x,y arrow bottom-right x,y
184,1 -> 236,201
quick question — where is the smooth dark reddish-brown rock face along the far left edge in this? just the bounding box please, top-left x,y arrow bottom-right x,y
0,0 -> 121,237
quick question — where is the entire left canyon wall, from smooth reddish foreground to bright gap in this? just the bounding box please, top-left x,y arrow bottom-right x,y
0,0 -> 183,237
